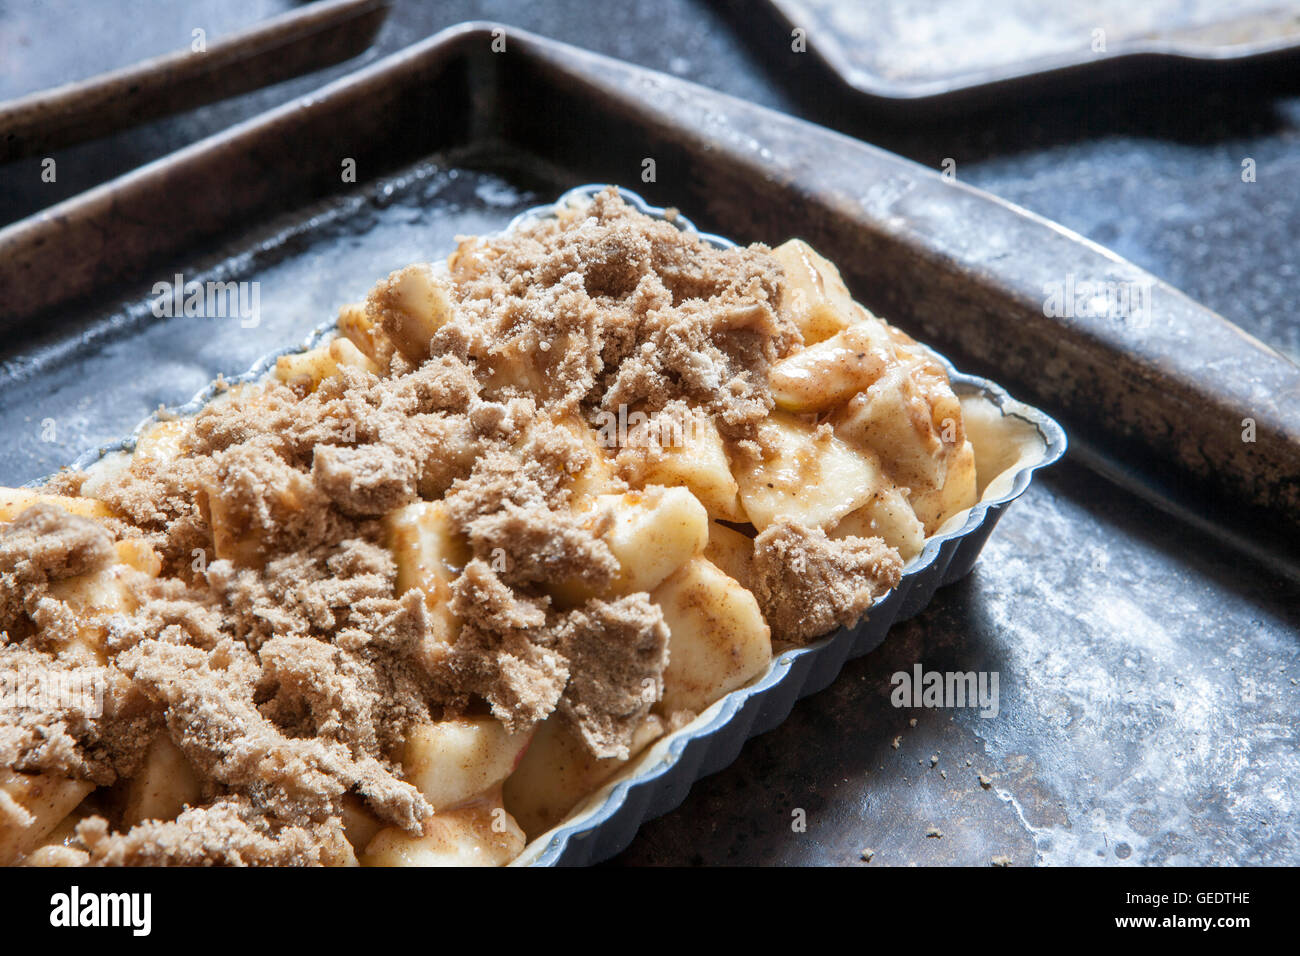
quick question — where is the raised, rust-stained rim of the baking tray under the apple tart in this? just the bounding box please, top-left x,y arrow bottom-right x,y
0,23 -> 1300,575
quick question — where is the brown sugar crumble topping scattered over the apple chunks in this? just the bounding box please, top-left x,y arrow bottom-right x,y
0,191 -> 956,865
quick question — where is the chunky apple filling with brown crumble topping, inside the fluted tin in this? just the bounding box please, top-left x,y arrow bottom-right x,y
0,190 -> 976,865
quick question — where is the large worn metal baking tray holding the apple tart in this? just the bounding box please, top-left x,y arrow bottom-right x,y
0,25 -> 1300,862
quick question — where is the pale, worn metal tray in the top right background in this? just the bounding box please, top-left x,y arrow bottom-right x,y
767,0 -> 1300,108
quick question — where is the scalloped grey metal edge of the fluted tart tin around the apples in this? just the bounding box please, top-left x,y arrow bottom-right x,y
25,183 -> 1066,866
